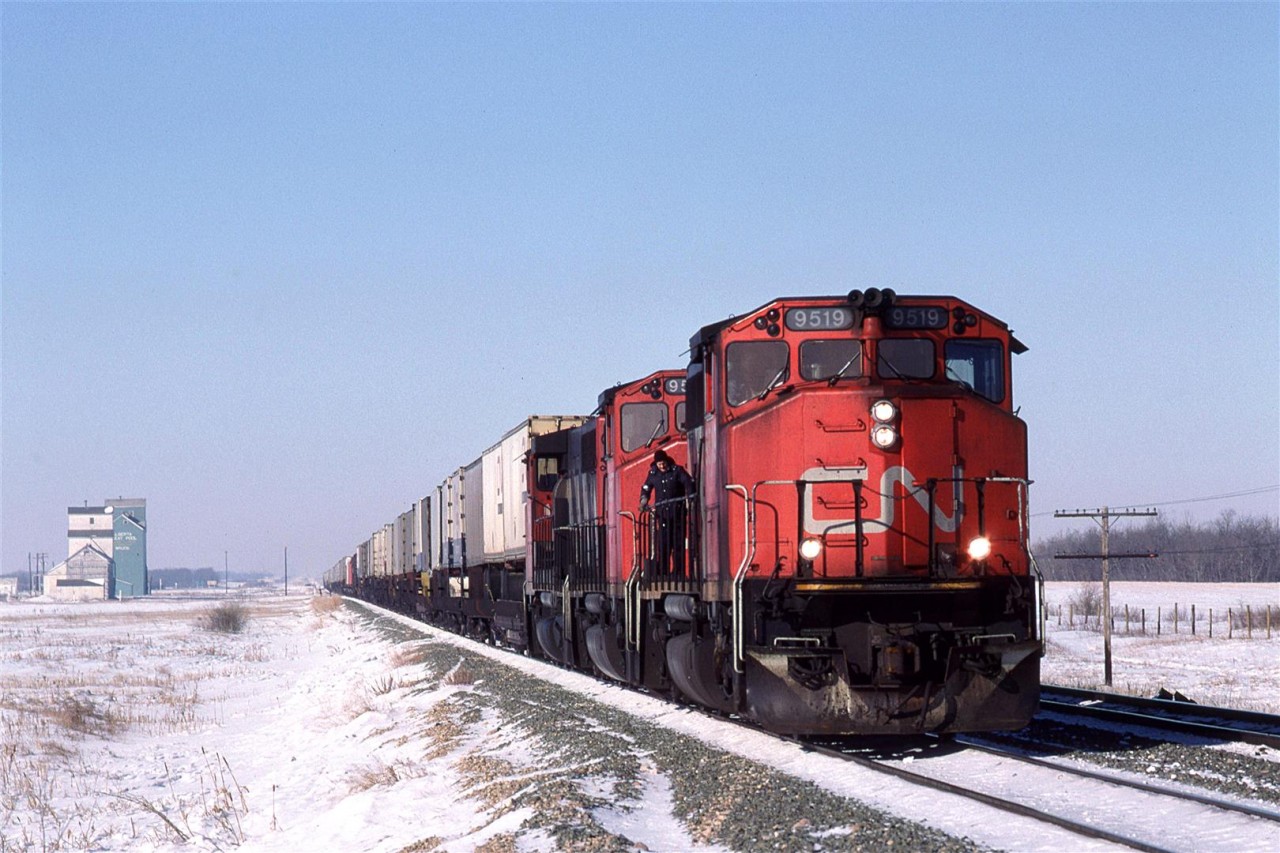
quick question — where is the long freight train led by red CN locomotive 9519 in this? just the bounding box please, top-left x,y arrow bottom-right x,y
326,288 -> 1043,734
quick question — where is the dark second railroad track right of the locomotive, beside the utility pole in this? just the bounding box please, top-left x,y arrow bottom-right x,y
1041,685 -> 1280,749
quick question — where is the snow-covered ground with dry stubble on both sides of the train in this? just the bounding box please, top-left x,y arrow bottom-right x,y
0,584 -> 1280,853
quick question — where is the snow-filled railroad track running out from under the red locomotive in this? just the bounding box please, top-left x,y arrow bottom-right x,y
799,739 -> 1280,852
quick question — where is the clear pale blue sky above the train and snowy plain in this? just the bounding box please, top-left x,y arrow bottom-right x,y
0,3 -> 1280,575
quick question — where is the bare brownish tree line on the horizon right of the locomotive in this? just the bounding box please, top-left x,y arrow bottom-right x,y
1032,510 -> 1280,583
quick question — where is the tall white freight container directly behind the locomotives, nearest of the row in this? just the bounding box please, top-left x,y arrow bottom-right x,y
481,415 -> 585,562
